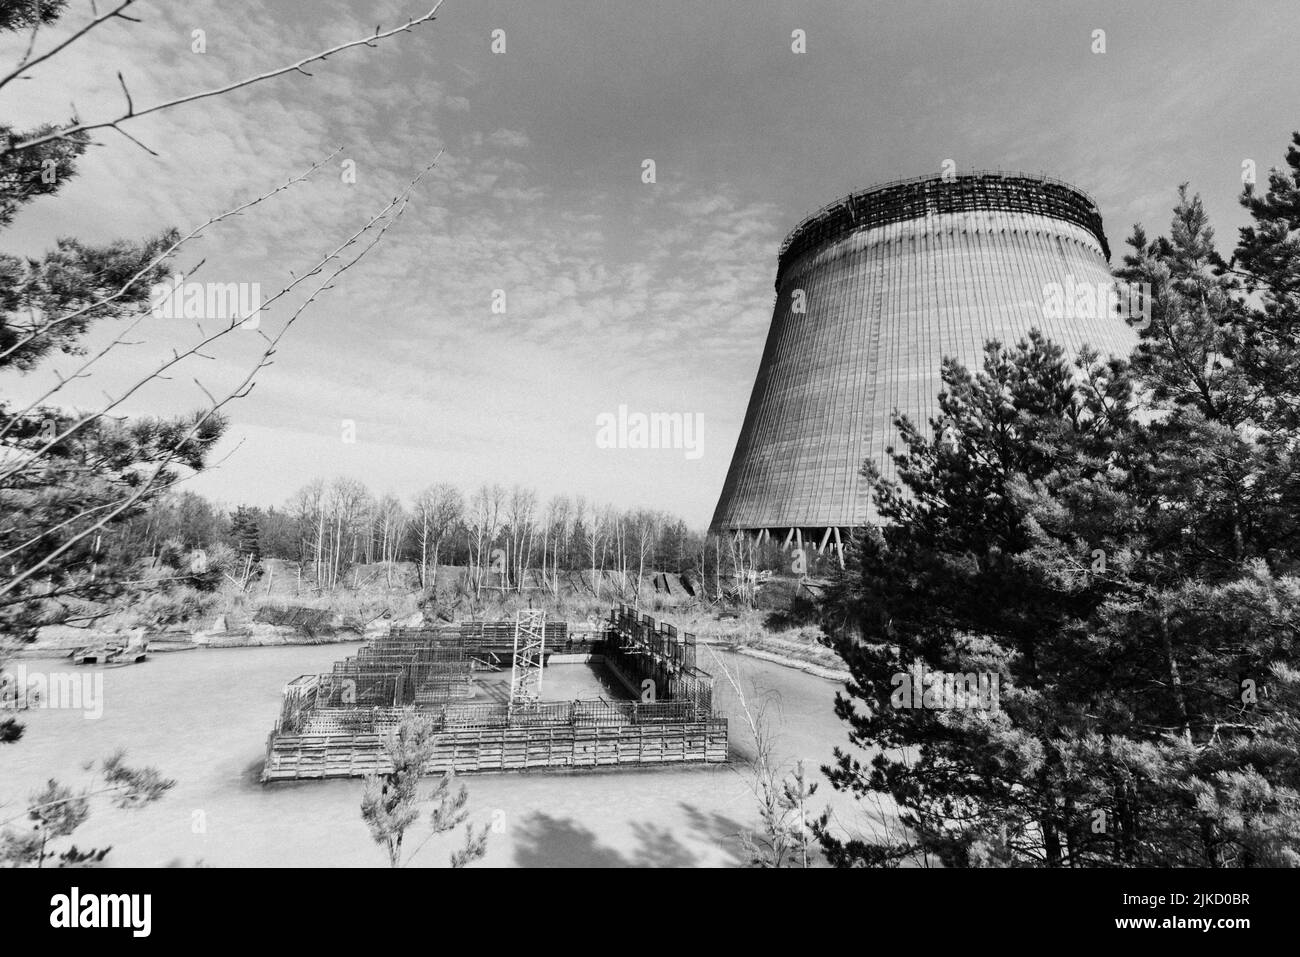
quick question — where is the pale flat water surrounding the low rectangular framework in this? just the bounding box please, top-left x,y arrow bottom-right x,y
0,645 -> 873,867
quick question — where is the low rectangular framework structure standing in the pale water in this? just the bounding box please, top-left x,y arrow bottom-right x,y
263,606 -> 728,781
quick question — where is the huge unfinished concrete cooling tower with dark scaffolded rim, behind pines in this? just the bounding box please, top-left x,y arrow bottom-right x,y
711,173 -> 1136,547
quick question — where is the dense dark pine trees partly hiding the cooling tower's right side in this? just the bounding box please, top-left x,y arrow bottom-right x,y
820,130 -> 1300,866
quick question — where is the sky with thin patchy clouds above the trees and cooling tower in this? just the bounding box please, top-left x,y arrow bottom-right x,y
0,0 -> 1300,527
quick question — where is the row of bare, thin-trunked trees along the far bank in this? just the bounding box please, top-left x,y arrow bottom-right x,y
116,479 -> 735,592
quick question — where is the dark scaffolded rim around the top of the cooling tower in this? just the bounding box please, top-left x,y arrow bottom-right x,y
776,170 -> 1110,287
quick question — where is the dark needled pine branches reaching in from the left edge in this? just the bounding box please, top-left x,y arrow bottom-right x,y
0,0 -> 225,647
